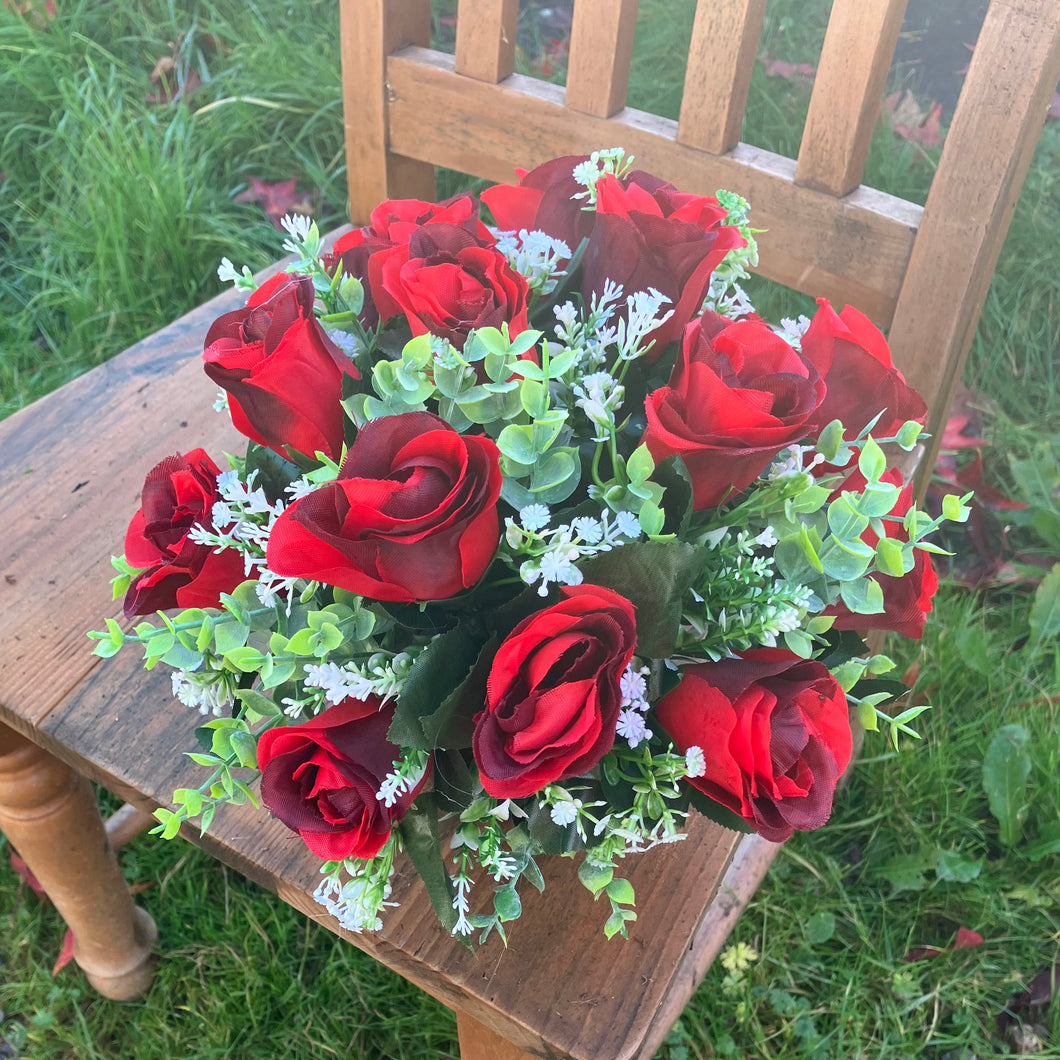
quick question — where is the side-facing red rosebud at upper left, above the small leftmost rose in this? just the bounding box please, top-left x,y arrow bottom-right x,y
202,272 -> 360,460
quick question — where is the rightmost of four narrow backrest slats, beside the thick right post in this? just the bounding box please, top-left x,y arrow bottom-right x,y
795,0 -> 906,195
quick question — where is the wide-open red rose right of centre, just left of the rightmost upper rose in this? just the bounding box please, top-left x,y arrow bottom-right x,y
644,312 -> 825,510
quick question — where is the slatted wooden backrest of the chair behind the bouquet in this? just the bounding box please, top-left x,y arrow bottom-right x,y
341,0 -> 1060,467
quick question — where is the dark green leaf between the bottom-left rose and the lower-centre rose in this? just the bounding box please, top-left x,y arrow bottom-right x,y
389,626 -> 482,750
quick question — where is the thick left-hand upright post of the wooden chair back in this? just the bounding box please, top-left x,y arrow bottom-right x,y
339,0 -> 435,225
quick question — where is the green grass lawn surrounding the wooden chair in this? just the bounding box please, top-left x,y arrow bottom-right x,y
0,0 -> 1060,1060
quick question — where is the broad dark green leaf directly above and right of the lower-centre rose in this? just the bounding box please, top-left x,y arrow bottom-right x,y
582,541 -> 706,658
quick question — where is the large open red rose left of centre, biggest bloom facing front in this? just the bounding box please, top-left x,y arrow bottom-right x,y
267,412 -> 501,602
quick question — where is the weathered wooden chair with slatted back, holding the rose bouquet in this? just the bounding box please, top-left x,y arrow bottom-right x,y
0,0 -> 1060,1060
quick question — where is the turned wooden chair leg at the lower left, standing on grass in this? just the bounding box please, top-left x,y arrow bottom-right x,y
0,725 -> 157,1001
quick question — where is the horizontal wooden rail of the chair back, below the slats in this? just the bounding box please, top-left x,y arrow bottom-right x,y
388,49 -> 921,324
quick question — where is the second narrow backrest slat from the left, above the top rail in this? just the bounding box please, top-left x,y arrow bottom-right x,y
566,0 -> 637,118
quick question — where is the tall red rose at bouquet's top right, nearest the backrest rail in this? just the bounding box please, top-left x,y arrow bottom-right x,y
582,173 -> 744,359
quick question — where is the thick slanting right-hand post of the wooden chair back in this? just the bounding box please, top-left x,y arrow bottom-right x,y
889,0 -> 1060,487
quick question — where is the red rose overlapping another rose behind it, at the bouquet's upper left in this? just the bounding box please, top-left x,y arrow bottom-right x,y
375,223 -> 529,350
